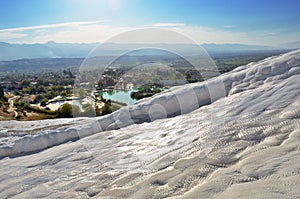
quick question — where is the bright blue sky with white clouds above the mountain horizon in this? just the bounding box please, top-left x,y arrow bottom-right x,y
0,0 -> 300,45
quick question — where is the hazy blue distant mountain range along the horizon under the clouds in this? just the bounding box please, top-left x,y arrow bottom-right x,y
0,41 -> 300,61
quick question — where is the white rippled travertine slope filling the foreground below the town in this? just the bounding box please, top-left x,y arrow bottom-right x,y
0,51 -> 300,198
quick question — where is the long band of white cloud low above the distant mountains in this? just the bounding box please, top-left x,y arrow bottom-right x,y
0,21 -> 292,45
